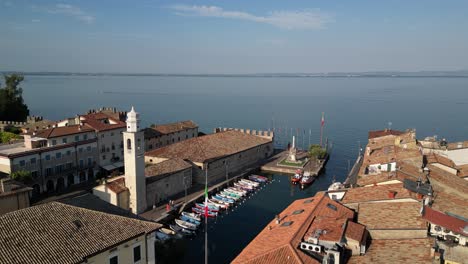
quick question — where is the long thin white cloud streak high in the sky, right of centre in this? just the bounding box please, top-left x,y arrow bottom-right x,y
169,5 -> 333,29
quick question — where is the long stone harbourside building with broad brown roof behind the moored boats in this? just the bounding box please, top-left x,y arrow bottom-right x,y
145,130 -> 273,183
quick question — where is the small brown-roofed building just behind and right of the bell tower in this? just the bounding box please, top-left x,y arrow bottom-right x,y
144,120 -> 198,151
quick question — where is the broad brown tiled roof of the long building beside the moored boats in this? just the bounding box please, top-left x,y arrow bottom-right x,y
145,130 -> 271,162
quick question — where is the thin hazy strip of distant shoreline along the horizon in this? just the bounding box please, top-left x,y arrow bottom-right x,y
1,71 -> 468,78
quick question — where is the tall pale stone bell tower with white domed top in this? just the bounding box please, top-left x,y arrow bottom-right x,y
123,106 -> 146,214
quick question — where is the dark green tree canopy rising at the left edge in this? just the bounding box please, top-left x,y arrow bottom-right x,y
0,74 -> 29,121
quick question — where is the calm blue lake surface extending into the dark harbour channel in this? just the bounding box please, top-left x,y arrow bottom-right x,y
22,76 -> 468,263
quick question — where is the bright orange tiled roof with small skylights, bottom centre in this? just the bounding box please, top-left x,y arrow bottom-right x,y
232,192 -> 354,264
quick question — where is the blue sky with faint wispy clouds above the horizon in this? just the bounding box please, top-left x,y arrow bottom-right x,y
0,0 -> 468,74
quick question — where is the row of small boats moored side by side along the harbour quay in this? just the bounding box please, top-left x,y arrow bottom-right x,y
170,175 -> 268,235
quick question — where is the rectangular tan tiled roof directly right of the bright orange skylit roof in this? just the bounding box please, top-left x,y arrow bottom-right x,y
358,201 -> 426,230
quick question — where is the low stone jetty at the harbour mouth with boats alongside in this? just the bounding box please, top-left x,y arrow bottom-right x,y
260,150 -> 329,176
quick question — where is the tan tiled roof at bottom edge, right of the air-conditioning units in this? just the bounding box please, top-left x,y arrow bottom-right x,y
348,238 -> 434,264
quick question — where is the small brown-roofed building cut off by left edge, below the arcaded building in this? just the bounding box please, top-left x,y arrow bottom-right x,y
0,179 -> 32,215
